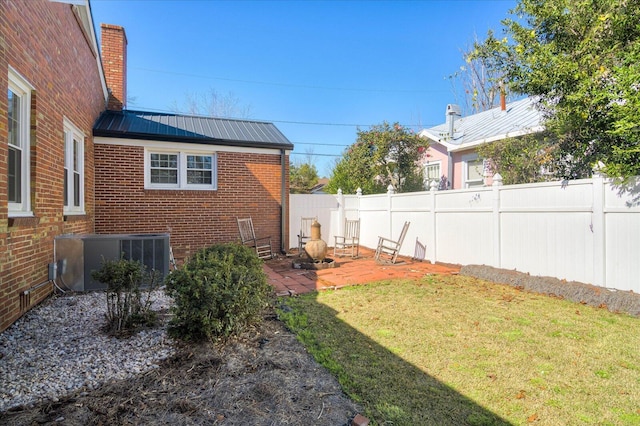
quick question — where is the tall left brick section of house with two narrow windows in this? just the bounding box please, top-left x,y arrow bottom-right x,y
0,0 -> 108,331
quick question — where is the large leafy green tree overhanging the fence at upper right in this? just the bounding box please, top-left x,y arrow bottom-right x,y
473,0 -> 640,178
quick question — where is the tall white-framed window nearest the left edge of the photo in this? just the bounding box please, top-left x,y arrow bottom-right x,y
7,67 -> 33,217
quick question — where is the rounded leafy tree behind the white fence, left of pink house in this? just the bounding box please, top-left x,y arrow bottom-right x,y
327,122 -> 429,194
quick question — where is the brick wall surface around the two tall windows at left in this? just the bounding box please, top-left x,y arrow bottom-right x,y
0,0 -> 105,331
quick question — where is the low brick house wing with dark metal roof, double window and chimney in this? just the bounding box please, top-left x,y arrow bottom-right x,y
93,25 -> 293,261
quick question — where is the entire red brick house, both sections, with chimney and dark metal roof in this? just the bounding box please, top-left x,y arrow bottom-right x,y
0,0 -> 293,331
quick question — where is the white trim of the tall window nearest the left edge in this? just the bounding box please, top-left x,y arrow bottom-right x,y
7,66 -> 34,217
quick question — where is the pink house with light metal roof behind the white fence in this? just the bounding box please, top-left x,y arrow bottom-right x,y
419,98 -> 544,189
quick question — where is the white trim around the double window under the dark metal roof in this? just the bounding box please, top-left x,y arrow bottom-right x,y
144,148 -> 218,191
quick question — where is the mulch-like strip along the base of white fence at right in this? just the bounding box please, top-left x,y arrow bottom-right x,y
460,265 -> 640,316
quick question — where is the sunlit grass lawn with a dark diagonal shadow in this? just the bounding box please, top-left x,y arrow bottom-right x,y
280,276 -> 640,425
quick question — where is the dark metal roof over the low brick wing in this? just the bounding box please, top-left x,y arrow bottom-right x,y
93,110 -> 293,150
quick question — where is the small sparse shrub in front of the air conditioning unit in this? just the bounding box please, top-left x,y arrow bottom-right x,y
91,259 -> 159,335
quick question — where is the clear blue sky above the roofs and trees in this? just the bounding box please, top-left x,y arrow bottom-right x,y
91,0 -> 516,177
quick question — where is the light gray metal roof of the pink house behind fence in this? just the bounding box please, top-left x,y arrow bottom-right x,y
420,98 -> 544,151
